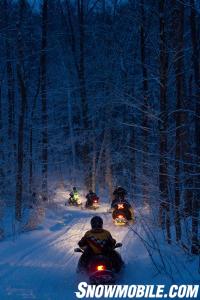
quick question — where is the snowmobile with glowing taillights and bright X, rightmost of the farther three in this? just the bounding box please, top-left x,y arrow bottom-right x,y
112,202 -> 133,226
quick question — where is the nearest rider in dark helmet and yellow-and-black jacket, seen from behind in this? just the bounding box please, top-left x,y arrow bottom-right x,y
78,216 -> 124,272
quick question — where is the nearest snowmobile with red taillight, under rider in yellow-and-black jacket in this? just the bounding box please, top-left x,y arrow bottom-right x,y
74,243 -> 122,285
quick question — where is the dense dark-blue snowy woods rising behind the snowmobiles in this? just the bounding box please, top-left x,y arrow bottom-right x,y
0,0 -> 200,254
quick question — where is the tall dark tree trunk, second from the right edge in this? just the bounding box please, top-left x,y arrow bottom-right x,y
173,0 -> 185,241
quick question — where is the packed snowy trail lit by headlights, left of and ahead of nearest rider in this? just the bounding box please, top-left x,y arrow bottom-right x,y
0,207 -> 138,300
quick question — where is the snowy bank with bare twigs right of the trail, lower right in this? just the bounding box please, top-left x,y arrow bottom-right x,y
127,208 -> 200,284
